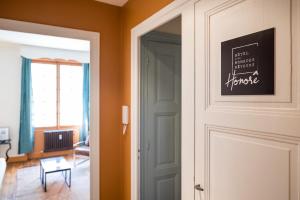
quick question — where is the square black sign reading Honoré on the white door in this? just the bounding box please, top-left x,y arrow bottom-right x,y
221,28 -> 275,95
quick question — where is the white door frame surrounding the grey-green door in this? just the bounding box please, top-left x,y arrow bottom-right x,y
131,0 -> 198,200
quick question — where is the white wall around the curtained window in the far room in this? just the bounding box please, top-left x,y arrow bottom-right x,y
0,41 -> 90,157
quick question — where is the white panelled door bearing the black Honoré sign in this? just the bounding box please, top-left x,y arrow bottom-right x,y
195,0 -> 300,200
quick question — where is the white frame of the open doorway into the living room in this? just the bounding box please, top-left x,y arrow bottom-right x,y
0,18 -> 100,199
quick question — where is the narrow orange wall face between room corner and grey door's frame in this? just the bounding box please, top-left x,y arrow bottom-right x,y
121,0 -> 173,200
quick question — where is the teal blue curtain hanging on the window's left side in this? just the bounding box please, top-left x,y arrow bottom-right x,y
19,57 -> 34,154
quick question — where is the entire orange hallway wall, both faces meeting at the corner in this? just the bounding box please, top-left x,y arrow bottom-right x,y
0,0 -> 173,200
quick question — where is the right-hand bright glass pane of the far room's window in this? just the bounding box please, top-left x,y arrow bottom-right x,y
60,65 -> 83,126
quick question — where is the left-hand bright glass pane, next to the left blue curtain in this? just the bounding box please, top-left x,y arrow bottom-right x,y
31,63 -> 56,127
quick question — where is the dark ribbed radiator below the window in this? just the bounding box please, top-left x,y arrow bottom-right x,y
44,130 -> 73,152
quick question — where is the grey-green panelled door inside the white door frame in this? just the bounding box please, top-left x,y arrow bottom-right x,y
140,33 -> 181,200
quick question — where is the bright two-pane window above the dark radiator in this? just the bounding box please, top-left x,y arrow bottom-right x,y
32,61 -> 83,127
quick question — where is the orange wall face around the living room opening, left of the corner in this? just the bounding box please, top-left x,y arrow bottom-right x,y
0,0 -> 122,200
